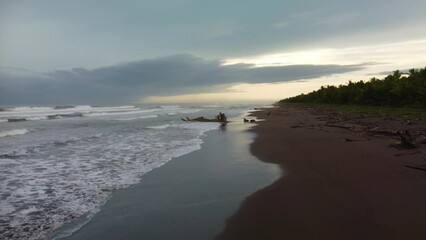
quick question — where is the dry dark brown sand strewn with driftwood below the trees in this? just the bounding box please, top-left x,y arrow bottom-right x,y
218,106 -> 426,239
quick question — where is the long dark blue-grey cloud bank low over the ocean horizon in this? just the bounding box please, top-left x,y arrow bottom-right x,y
0,55 -> 365,104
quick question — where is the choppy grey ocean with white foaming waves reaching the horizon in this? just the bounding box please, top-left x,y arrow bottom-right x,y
0,105 -> 254,239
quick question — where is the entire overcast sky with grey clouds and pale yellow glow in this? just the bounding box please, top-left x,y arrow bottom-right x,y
0,0 -> 426,105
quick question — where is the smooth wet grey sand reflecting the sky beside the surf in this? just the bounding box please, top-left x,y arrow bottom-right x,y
53,119 -> 281,240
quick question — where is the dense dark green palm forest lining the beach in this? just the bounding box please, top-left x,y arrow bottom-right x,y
280,67 -> 426,107
